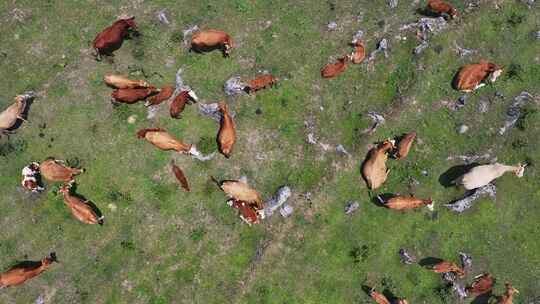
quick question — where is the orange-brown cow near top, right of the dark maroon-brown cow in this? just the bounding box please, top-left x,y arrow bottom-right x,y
191,30 -> 234,57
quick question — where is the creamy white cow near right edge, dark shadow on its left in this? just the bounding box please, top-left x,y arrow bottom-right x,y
455,163 -> 526,190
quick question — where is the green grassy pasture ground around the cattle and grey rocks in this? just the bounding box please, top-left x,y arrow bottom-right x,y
0,0 -> 540,304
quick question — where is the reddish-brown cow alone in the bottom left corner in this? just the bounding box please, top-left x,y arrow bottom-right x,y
0,252 -> 57,289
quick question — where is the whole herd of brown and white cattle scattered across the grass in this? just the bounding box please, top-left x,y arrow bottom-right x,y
0,0 -> 525,304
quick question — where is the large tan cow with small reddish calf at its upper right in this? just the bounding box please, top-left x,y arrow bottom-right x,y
362,140 -> 394,190
